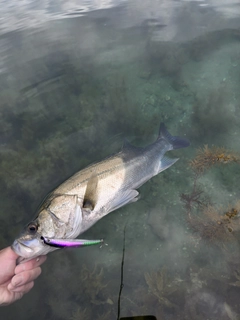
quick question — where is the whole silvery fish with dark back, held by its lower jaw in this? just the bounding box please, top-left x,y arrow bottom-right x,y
11,123 -> 190,263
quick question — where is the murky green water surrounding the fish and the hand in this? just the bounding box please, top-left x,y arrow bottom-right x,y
0,0 -> 240,320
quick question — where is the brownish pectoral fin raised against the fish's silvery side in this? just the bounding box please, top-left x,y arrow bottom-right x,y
83,174 -> 98,211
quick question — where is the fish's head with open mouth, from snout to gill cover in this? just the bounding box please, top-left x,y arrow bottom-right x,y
12,195 -> 83,262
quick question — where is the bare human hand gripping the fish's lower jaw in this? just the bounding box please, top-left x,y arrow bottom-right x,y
0,247 -> 47,306
